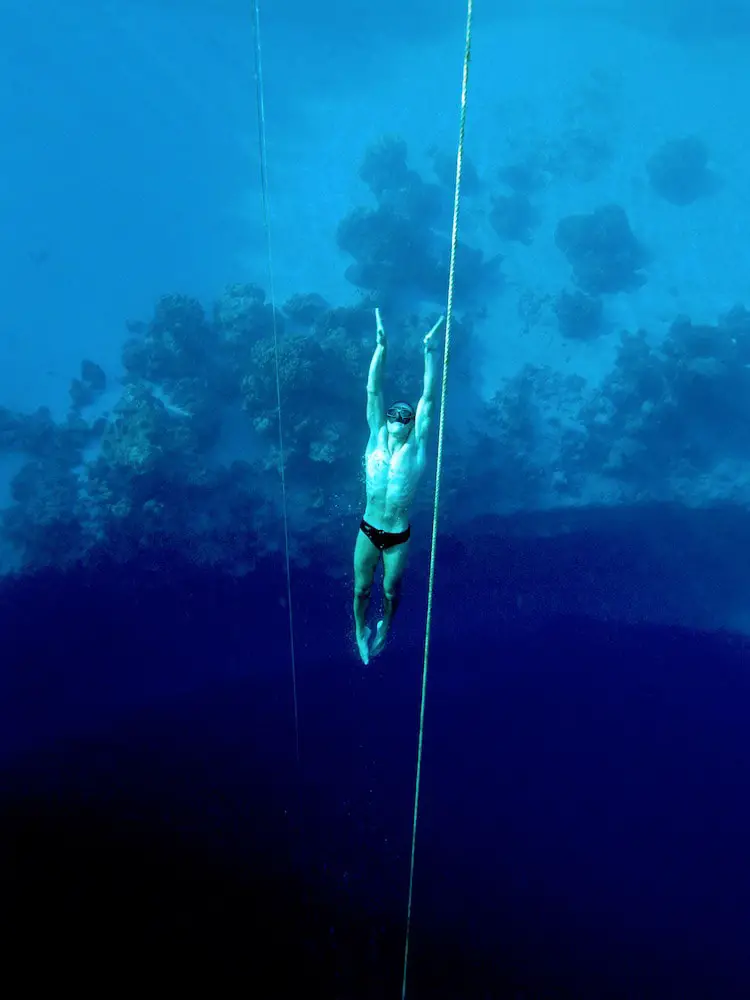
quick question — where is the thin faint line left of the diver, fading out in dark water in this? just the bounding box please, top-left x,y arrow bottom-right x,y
252,0 -> 300,764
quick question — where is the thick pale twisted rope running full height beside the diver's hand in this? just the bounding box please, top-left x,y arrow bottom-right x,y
401,0 -> 474,1000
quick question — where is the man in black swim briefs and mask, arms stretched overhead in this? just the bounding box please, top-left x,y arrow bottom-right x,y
354,309 -> 444,664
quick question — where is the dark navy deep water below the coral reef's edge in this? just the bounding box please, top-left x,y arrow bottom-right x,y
0,520 -> 750,998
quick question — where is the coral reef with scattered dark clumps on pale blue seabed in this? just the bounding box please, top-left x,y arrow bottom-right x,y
0,139 -> 750,572
